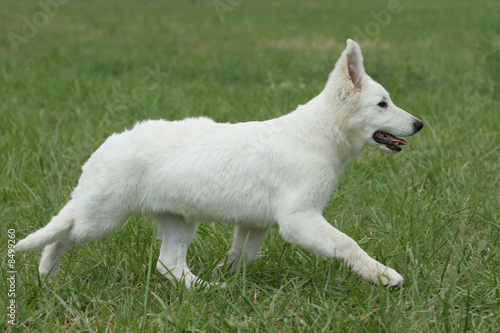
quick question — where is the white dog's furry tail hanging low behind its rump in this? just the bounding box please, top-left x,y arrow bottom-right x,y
15,200 -> 75,252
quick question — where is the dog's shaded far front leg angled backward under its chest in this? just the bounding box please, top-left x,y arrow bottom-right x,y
214,226 -> 269,273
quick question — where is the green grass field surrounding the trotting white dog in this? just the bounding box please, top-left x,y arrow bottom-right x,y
0,0 -> 500,332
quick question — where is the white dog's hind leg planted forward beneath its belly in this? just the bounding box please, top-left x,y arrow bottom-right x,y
153,214 -> 206,289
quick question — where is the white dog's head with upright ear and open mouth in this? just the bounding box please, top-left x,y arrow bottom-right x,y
327,39 -> 424,153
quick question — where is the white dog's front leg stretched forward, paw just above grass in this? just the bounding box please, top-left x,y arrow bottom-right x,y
278,212 -> 404,287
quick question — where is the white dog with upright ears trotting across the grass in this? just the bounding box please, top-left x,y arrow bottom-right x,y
16,40 -> 423,288
